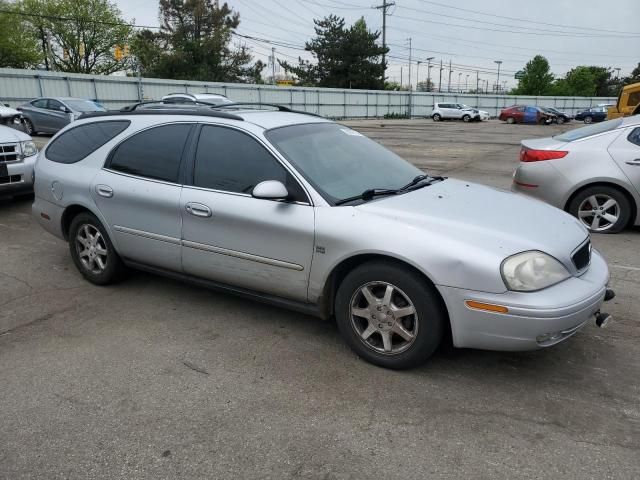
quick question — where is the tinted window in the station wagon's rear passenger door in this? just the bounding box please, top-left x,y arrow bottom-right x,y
107,123 -> 191,183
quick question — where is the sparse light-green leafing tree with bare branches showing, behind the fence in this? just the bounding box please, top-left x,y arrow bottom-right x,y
20,0 -> 132,75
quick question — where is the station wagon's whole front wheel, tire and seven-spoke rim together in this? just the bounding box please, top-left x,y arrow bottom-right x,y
335,262 -> 446,369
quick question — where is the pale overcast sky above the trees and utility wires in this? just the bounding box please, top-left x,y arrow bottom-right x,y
116,0 -> 640,91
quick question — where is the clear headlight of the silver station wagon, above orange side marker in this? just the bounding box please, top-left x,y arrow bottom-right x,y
502,251 -> 571,292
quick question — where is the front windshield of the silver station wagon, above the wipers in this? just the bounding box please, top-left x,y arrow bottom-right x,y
266,123 -> 423,203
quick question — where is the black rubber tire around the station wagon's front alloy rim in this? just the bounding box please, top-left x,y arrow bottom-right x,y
335,261 -> 448,370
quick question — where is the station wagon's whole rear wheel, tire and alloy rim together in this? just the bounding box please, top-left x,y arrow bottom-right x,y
69,213 -> 124,285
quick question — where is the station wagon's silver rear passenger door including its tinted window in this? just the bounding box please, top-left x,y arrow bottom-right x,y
91,123 -> 194,271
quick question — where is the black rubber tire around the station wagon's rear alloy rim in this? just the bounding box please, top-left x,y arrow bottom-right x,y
69,212 -> 126,285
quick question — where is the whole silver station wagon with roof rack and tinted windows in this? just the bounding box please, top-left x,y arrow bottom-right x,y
33,104 -> 614,368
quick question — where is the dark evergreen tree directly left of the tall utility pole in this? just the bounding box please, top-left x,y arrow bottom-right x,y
280,15 -> 388,89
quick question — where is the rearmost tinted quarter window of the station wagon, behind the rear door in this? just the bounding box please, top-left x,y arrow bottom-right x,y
45,120 -> 131,163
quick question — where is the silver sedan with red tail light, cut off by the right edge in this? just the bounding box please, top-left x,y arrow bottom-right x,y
512,115 -> 640,233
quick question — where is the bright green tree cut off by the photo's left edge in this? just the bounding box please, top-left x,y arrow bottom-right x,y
0,0 -> 42,68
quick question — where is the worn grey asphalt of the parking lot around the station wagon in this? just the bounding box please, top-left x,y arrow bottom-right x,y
0,120 -> 640,479
